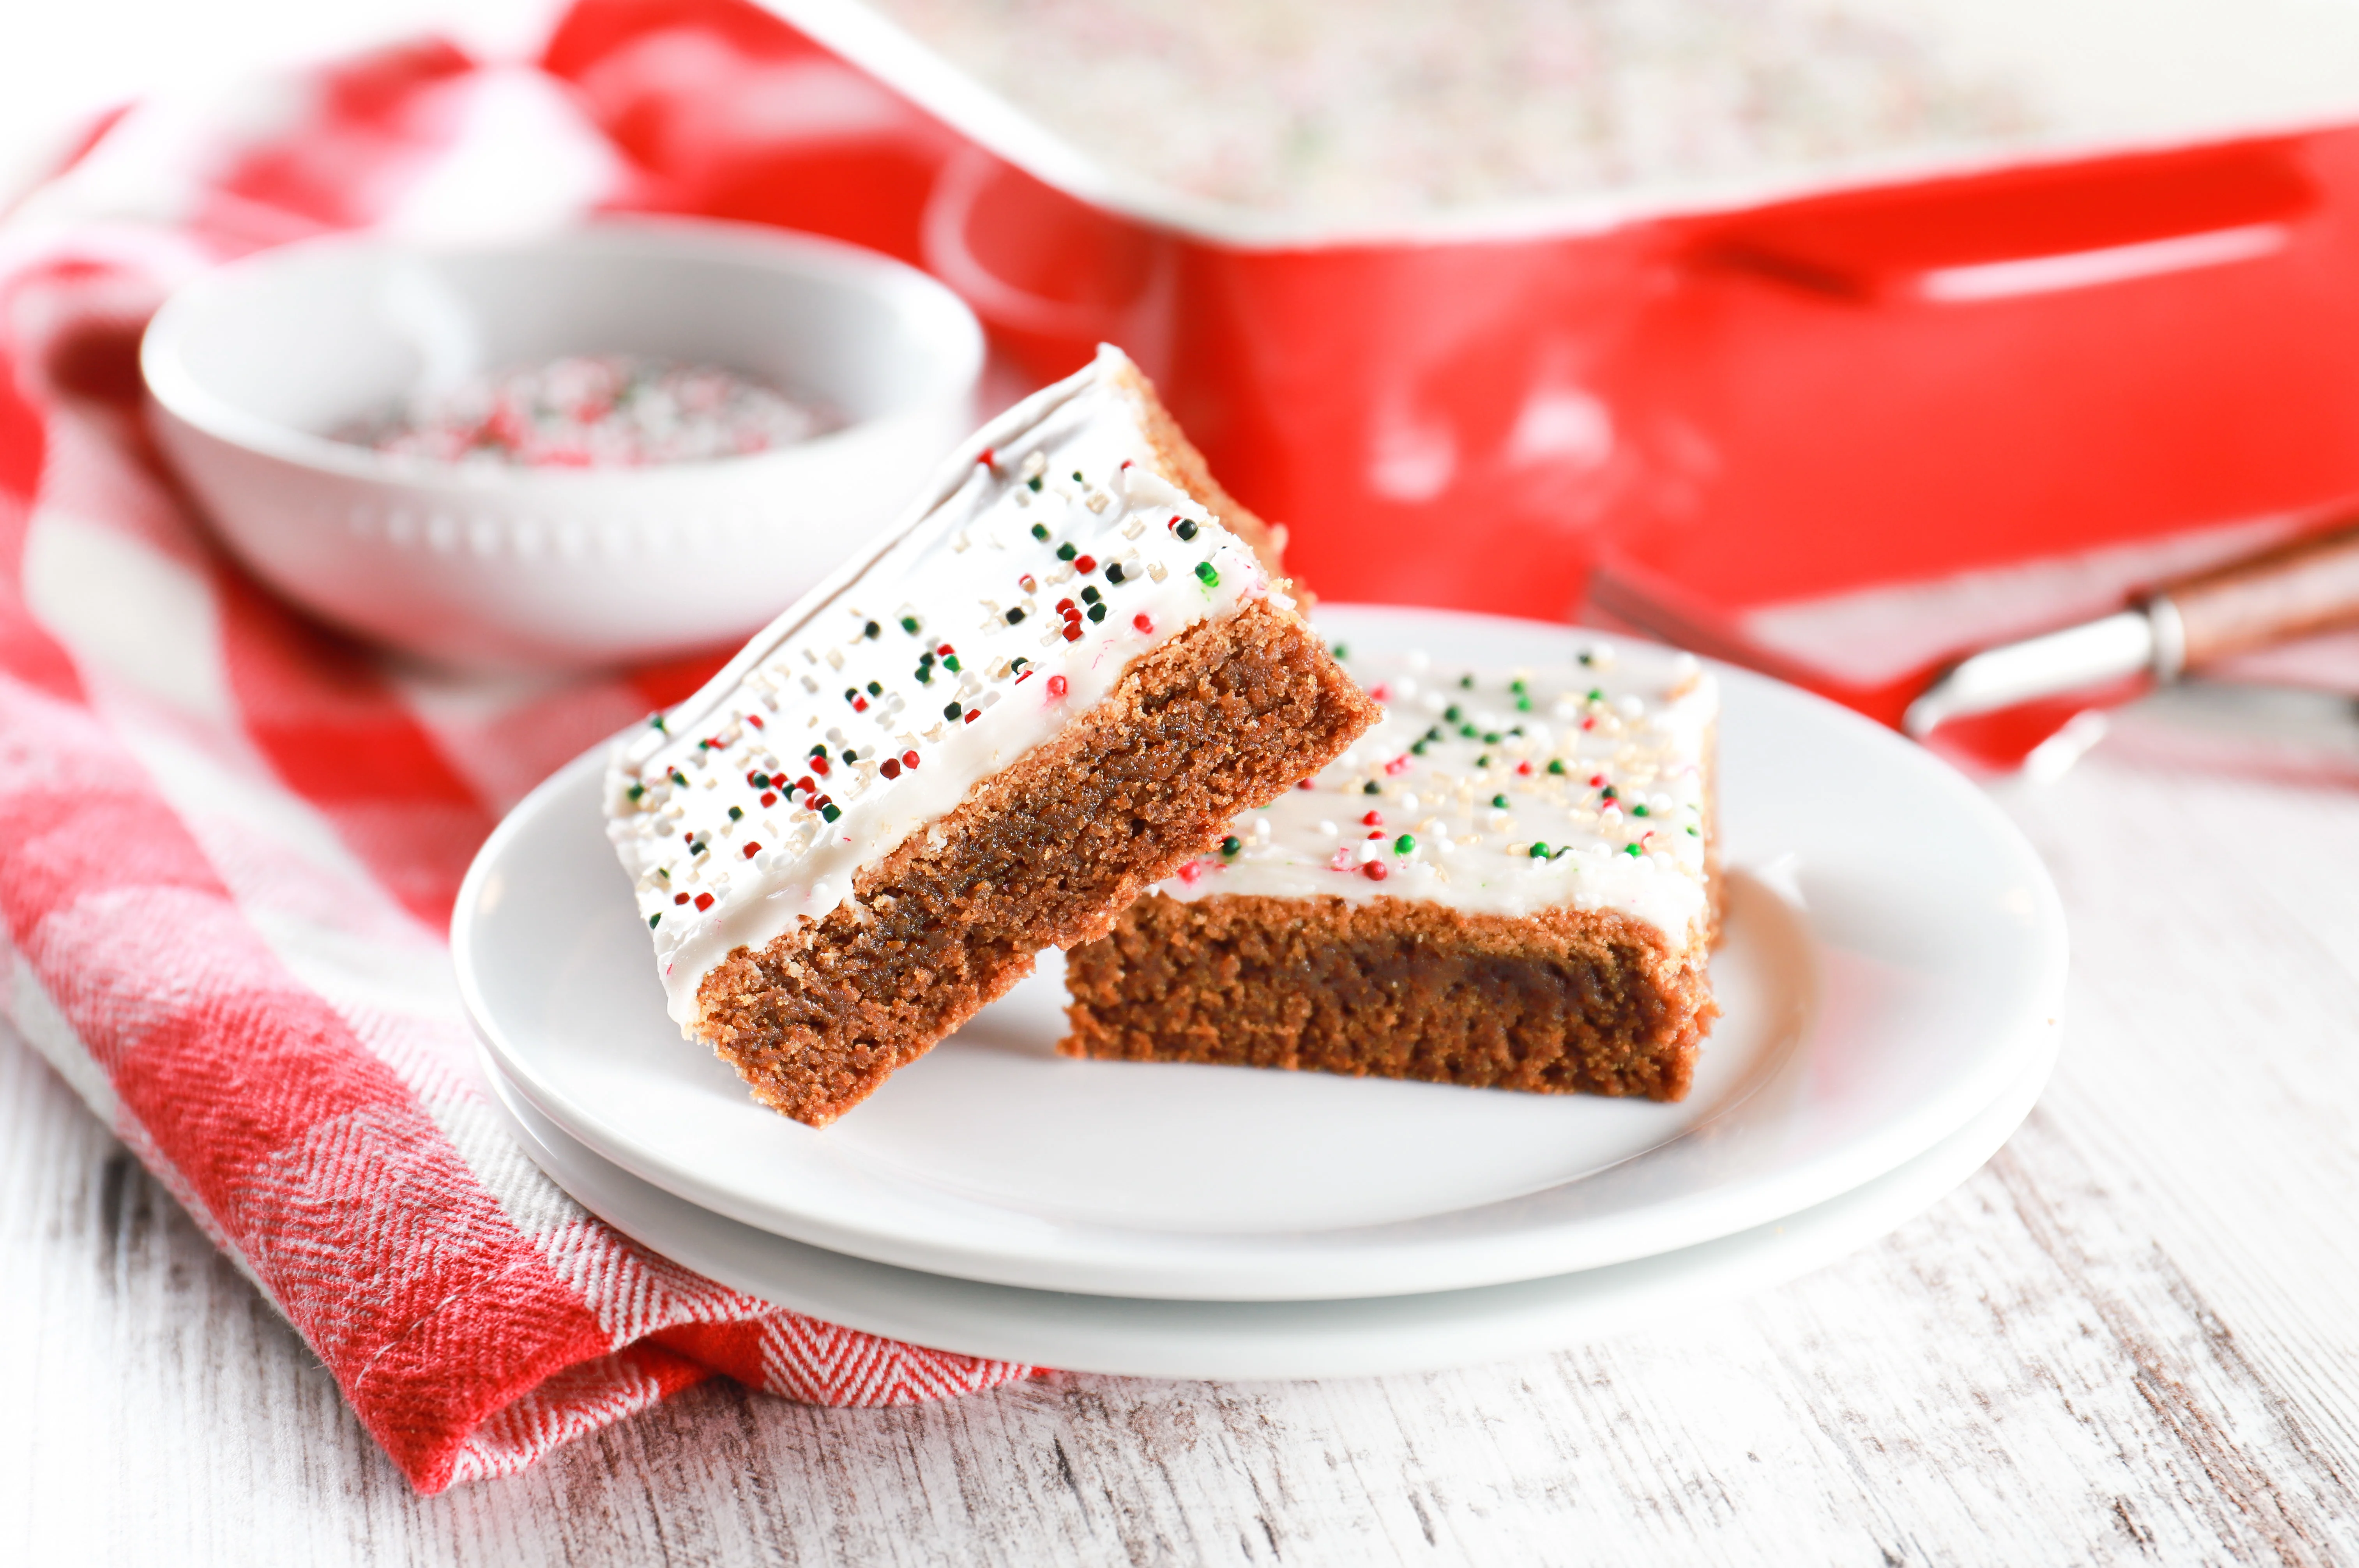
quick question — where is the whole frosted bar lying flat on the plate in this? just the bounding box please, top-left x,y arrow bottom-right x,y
1059,639 -> 1720,1099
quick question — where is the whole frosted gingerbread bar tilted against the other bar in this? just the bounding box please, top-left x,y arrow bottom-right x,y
606,349 -> 1378,1125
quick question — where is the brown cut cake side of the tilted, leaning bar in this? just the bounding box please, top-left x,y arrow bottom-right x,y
696,599 -> 1378,1127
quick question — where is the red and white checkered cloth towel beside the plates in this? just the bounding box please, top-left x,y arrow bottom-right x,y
0,0 -> 1028,1492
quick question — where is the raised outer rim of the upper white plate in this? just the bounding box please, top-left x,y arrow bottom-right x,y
451,606 -> 2069,1299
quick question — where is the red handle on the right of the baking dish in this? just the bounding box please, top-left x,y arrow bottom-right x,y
1701,141 -> 2319,304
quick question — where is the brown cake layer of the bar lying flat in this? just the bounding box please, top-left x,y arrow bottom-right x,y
1057,891 -> 1720,1101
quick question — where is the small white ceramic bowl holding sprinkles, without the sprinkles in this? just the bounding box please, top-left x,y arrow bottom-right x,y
139,219 -> 984,667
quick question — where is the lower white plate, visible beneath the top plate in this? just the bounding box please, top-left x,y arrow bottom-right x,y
474,1031 -> 2057,1379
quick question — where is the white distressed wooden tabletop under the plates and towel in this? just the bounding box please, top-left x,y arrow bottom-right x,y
0,693 -> 2359,1566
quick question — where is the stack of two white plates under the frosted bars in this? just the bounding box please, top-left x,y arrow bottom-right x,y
453,606 -> 2064,1377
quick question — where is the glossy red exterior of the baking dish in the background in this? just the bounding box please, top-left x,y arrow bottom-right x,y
547,0 -> 2359,655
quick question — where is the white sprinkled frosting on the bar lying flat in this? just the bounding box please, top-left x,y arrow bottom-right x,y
1158,636 -> 1720,953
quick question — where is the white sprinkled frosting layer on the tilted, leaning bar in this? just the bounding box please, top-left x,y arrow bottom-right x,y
606,349 -> 1290,1031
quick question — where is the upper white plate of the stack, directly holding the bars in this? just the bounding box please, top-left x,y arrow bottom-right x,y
453,608 -> 2064,1301
